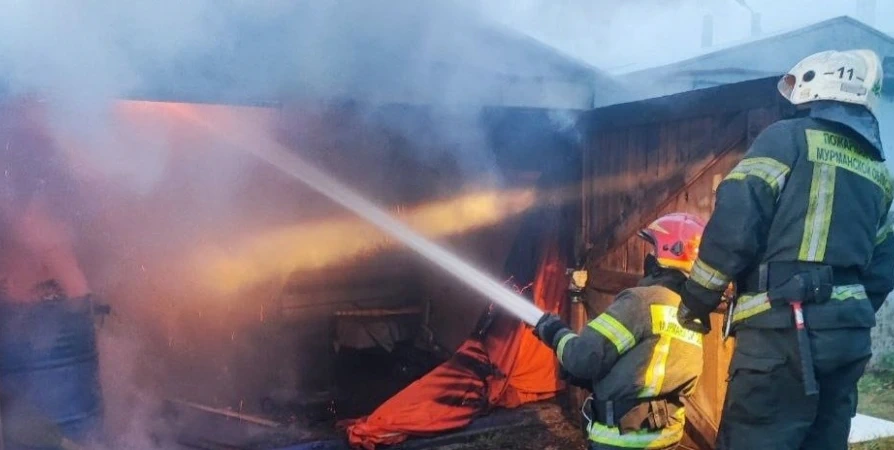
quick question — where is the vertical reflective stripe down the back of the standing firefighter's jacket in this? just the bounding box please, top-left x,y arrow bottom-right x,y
798,164 -> 835,261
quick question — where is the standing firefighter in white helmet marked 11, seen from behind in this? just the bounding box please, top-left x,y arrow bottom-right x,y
679,50 -> 894,450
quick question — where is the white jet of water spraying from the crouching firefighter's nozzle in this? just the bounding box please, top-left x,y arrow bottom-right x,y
179,109 -> 544,325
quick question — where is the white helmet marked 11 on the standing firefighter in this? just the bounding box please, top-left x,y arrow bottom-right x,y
777,50 -> 883,115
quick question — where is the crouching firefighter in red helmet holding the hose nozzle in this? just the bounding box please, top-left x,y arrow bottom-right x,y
534,214 -> 704,450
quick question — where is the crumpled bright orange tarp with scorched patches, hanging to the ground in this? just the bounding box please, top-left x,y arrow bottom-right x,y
347,240 -> 568,450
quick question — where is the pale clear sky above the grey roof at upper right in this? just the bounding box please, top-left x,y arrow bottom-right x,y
478,0 -> 894,72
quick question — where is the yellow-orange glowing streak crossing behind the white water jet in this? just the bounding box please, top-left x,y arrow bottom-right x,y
190,189 -> 535,294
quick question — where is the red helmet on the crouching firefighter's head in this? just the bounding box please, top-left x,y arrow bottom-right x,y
638,213 -> 705,273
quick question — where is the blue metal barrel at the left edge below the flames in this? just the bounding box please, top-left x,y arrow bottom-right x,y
0,298 -> 103,449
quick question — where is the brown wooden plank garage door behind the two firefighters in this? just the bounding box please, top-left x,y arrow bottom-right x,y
572,78 -> 792,442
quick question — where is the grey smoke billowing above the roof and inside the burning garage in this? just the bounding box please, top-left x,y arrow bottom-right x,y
0,0 -> 588,449
